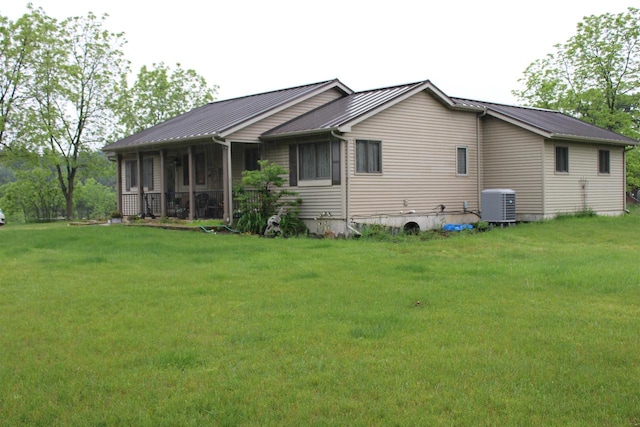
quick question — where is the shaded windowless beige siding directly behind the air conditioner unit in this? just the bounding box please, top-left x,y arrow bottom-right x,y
482,117 -> 544,215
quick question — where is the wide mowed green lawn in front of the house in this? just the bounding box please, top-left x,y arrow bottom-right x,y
0,219 -> 640,426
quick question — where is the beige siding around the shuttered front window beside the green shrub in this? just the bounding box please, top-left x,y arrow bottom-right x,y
266,141 -> 345,219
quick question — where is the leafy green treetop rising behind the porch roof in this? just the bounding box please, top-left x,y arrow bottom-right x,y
113,62 -> 218,139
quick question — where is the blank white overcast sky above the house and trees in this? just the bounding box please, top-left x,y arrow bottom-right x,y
0,0 -> 640,104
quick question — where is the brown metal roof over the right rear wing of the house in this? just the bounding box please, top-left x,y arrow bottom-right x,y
451,98 -> 638,145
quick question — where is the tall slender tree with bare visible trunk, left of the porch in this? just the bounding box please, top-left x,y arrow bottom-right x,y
14,13 -> 128,219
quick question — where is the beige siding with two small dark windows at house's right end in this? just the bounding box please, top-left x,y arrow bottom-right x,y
544,141 -> 624,216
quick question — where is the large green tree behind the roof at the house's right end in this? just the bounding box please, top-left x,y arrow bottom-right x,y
513,7 -> 640,139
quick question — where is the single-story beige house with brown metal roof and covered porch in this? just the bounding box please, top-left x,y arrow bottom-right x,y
103,80 -> 637,234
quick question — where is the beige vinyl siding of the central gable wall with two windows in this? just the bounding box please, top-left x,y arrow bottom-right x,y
347,92 -> 478,216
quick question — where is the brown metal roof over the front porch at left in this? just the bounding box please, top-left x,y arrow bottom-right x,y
103,79 -> 350,151
